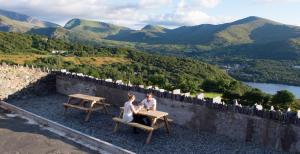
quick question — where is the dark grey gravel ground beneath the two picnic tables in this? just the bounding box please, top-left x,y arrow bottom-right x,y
8,94 -> 288,154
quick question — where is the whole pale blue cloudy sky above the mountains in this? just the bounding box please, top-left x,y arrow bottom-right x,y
0,0 -> 300,29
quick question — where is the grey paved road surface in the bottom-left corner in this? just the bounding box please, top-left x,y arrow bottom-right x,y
0,109 -> 97,154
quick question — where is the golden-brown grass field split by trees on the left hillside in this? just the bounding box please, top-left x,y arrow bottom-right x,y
0,54 -> 129,66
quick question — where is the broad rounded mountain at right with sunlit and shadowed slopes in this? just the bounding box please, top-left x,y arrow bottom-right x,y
108,17 -> 300,46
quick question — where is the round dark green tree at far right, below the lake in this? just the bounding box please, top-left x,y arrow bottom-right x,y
272,90 -> 295,110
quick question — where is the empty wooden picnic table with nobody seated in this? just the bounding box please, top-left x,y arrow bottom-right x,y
64,94 -> 109,121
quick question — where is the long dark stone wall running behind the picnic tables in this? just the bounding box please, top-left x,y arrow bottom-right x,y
56,72 -> 300,152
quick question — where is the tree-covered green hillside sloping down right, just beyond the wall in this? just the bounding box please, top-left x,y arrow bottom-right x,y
0,32 -> 247,93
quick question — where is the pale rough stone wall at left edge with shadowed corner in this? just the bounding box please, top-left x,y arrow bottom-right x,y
0,64 -> 56,100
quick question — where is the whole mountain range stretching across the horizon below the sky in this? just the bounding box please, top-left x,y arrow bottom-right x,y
0,10 -> 300,59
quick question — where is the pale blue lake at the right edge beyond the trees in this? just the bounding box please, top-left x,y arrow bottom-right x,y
244,82 -> 300,99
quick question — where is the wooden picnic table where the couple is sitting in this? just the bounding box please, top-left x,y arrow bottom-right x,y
113,107 -> 172,144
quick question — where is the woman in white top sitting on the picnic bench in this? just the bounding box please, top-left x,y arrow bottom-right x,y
123,93 -> 143,133
